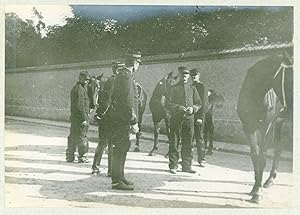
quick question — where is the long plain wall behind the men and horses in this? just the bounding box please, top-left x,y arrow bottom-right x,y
5,49 -> 290,146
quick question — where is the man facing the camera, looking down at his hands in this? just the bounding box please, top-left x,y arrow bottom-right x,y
166,67 -> 201,174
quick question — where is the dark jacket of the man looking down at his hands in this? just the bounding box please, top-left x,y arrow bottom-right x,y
166,81 -> 201,118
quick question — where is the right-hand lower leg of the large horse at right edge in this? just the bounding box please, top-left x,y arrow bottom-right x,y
264,119 -> 284,188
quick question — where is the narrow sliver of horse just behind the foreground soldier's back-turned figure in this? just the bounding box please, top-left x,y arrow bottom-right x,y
133,82 -> 147,152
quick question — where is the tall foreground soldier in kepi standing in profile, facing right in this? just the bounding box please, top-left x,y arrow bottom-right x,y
111,52 -> 141,190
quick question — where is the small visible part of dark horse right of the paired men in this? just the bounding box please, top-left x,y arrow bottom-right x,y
203,89 -> 224,155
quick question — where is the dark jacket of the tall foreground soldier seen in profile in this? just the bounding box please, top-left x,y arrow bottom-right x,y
111,67 -> 138,126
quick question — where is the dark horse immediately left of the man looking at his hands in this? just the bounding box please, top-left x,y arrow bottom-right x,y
148,72 -> 177,156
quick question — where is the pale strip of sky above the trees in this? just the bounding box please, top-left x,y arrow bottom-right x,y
5,5 -> 279,26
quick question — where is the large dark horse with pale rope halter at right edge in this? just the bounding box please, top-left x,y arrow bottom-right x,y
237,50 -> 293,204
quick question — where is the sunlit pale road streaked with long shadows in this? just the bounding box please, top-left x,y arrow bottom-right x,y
5,120 -> 293,208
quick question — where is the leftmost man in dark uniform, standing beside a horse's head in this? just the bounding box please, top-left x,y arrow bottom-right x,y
66,71 -> 90,163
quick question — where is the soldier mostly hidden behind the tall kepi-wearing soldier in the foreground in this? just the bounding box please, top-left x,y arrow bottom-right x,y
92,62 -> 124,177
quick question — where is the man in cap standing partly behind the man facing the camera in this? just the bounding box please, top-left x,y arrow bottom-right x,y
190,68 -> 208,167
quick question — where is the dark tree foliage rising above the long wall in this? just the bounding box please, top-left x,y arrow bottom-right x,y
5,7 -> 293,67
